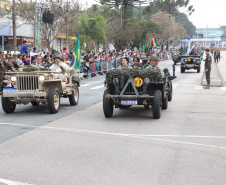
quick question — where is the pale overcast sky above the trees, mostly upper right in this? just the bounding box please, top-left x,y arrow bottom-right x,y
80,0 -> 226,28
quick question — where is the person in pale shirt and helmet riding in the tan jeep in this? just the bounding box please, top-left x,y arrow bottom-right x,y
49,54 -> 69,73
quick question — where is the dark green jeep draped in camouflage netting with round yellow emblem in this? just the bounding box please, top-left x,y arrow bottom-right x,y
103,66 -> 176,119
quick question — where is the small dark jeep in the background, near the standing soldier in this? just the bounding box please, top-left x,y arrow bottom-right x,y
181,55 -> 201,73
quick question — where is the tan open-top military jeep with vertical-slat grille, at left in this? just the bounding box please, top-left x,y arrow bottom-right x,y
2,68 -> 81,114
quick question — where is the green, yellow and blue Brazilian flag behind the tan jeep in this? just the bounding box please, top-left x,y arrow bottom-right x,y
70,35 -> 81,70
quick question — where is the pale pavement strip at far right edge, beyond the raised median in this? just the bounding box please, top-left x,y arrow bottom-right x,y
217,51 -> 226,87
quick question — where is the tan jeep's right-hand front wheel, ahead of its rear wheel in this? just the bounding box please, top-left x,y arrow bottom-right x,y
48,87 -> 60,114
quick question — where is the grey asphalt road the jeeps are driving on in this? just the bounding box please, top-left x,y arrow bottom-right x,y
0,61 -> 226,185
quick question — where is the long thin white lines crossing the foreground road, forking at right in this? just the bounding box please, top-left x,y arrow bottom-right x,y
0,123 -> 226,151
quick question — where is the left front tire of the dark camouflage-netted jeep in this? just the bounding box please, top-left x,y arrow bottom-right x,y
103,89 -> 114,118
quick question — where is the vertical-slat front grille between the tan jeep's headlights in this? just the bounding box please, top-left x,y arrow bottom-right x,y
17,76 -> 38,91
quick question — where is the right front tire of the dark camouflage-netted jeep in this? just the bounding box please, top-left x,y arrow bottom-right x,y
152,90 -> 162,119
